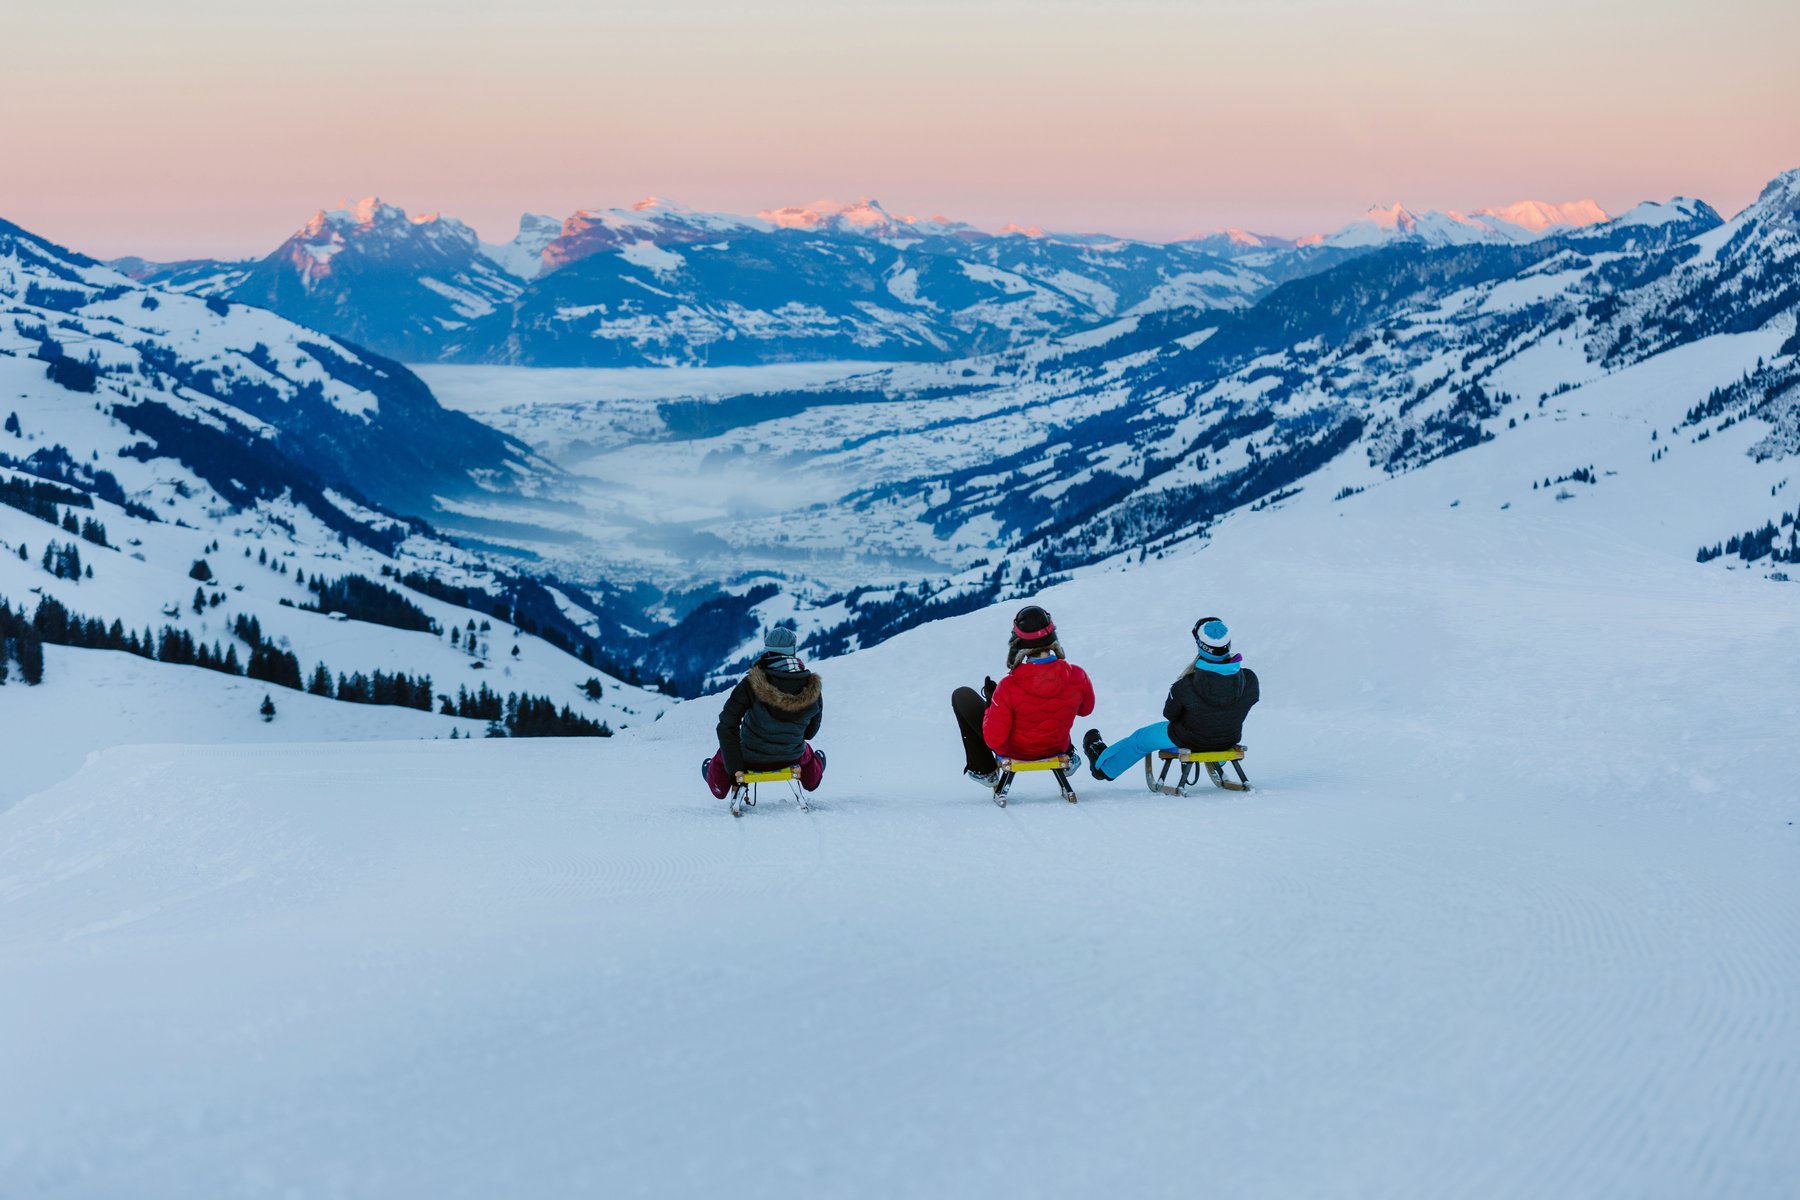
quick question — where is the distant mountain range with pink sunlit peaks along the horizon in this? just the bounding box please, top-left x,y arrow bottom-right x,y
117,189 -> 1606,367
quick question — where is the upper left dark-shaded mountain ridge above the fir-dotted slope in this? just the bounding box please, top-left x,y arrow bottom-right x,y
0,213 -> 553,520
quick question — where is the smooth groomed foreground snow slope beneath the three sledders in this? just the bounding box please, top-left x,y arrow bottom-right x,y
0,417 -> 1800,1198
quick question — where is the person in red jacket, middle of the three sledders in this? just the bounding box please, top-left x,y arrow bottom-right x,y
950,604 -> 1094,788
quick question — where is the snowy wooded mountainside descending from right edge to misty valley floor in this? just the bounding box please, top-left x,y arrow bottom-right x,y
414,175 -> 1800,676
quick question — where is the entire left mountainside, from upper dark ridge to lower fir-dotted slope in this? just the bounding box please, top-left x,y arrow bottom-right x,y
0,215 -> 676,759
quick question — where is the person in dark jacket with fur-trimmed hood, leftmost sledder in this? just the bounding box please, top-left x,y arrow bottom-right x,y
700,626 -> 824,799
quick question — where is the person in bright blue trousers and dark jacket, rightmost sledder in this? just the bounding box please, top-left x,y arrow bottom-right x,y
1082,617 -> 1262,779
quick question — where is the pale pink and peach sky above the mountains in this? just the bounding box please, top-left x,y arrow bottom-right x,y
0,0 -> 1800,257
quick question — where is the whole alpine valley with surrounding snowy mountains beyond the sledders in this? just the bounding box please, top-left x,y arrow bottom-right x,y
0,173 -> 1800,727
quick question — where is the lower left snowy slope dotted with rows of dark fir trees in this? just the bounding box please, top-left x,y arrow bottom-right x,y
0,460 -> 666,808
